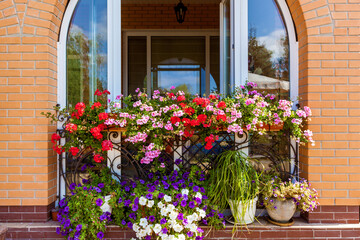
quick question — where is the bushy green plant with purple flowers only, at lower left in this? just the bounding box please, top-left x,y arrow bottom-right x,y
56,166 -> 115,239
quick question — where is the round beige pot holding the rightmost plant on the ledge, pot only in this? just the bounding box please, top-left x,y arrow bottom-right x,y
266,198 -> 296,223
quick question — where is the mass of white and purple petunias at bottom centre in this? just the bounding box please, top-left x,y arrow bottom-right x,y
112,160 -> 224,240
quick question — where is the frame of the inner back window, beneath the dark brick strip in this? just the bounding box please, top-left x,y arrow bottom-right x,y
123,29 -> 219,96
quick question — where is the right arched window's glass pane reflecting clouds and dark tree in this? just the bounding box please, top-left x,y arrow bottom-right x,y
248,0 -> 289,98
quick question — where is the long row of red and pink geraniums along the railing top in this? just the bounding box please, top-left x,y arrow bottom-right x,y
44,82 -> 314,171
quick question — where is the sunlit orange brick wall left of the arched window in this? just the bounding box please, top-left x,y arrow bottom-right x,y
0,0 -> 67,212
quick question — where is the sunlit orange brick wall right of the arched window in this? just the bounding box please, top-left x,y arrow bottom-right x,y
287,0 -> 360,205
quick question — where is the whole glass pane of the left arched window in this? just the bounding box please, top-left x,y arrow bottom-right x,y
66,0 -> 107,106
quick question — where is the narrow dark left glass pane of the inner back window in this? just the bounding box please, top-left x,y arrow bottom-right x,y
128,37 -> 147,94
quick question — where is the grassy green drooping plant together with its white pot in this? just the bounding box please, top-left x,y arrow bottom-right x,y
209,150 -> 261,224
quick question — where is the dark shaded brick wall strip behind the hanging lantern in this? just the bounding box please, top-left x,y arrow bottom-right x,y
121,3 -> 220,29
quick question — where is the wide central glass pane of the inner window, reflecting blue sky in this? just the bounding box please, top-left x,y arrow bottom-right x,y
151,37 -> 205,94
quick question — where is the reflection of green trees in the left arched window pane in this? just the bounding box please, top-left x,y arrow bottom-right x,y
66,31 -> 106,106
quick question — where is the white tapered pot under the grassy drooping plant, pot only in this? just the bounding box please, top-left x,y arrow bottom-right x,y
229,197 -> 258,225
